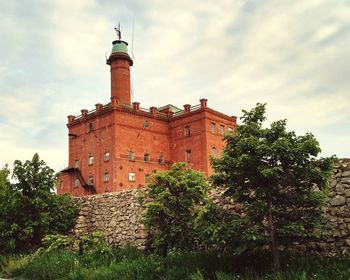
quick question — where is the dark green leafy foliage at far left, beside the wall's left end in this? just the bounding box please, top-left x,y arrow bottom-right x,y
0,154 -> 78,252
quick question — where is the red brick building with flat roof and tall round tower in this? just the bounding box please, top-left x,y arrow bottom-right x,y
57,34 -> 236,196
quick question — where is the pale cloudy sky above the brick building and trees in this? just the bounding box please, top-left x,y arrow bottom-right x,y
0,0 -> 350,171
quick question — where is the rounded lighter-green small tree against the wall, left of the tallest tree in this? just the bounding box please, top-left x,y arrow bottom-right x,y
143,163 -> 209,256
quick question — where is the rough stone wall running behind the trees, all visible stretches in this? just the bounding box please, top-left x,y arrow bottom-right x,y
74,159 -> 350,255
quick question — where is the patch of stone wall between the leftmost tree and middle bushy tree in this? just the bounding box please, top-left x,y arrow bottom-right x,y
73,190 -> 147,249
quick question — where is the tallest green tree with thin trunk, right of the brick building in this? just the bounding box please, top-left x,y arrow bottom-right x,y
212,103 -> 334,271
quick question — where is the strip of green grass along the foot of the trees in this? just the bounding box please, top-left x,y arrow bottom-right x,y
0,247 -> 350,280
